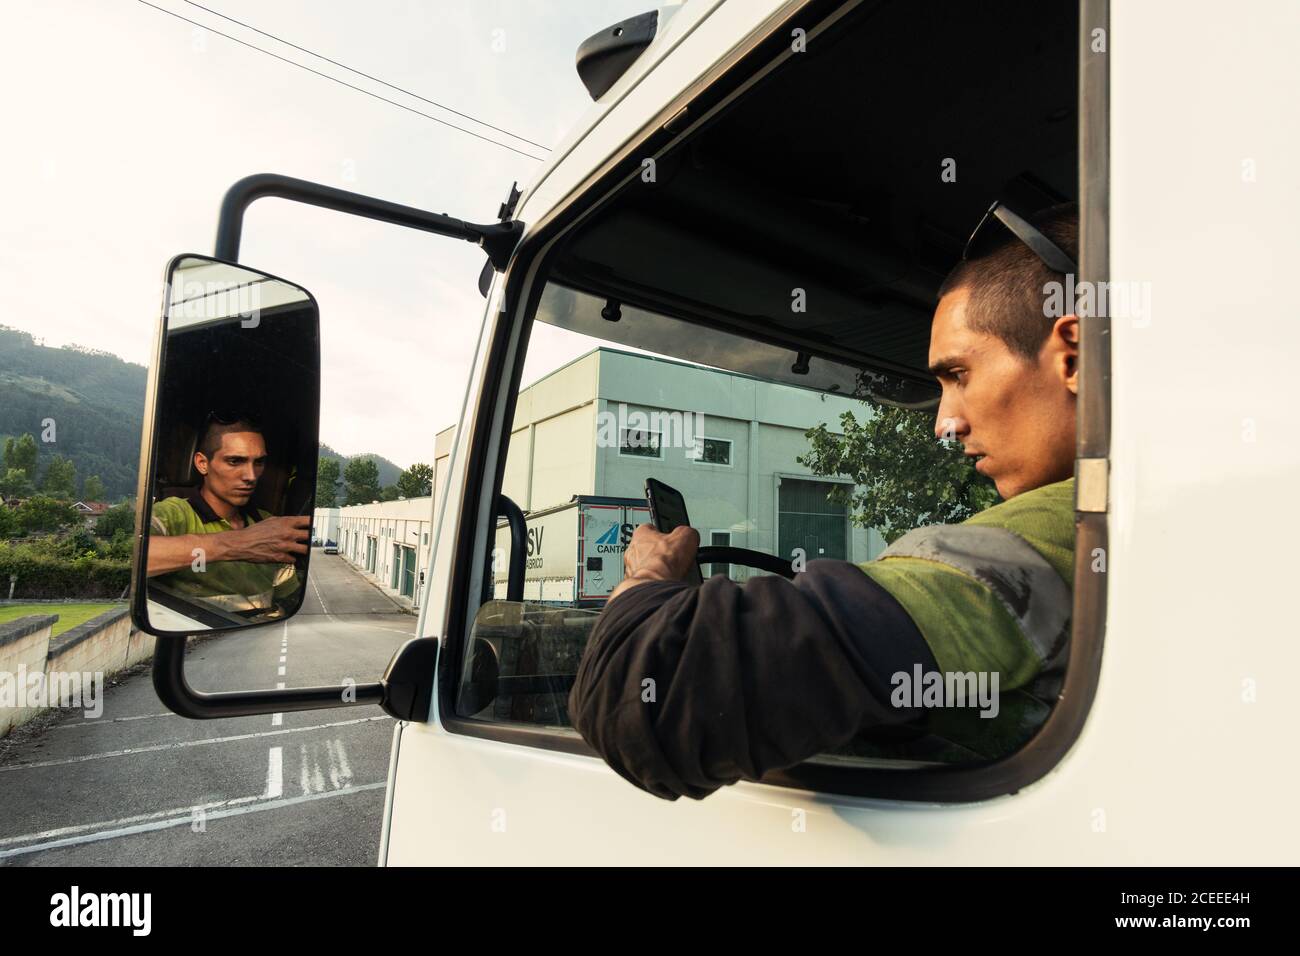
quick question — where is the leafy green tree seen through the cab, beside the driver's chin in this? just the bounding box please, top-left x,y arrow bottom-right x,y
797,398 -> 998,544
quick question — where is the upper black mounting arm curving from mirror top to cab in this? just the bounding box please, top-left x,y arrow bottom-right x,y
215,173 -> 524,272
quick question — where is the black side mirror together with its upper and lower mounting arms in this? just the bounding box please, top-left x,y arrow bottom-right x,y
131,173 -> 512,721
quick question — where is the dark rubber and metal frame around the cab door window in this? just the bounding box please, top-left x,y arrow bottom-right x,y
436,0 -> 1110,804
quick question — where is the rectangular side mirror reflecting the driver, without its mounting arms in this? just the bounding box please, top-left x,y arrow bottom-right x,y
131,255 -> 320,637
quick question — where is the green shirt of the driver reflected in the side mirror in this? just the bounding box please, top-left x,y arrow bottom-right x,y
150,489 -> 302,611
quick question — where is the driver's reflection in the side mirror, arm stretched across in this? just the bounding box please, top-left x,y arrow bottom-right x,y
148,415 -> 311,611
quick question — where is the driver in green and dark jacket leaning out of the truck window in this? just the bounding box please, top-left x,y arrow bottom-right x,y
569,203 -> 1079,800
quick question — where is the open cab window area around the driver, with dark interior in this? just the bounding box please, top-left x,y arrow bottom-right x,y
443,1 -> 1105,800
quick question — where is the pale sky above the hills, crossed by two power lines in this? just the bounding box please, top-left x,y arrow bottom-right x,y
0,0 -> 655,467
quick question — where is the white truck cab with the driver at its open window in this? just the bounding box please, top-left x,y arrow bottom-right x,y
133,0 -> 1300,865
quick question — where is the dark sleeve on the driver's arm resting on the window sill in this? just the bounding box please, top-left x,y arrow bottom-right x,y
569,561 -> 936,800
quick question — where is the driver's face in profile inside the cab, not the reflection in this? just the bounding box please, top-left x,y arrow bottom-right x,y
930,289 -> 1079,498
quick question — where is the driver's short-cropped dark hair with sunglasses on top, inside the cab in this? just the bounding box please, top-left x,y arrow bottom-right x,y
939,203 -> 1079,359
